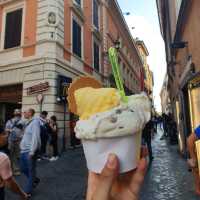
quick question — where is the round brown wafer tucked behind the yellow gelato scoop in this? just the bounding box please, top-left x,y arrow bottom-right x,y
67,76 -> 102,114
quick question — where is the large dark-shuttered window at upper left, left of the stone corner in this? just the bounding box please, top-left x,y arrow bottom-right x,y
4,9 -> 22,49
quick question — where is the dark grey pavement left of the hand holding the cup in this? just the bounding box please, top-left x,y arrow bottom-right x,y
6,148 -> 87,200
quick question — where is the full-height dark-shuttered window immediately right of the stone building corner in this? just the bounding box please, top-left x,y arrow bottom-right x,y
73,19 -> 82,58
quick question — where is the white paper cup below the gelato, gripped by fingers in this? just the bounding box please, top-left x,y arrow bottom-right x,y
82,133 -> 141,173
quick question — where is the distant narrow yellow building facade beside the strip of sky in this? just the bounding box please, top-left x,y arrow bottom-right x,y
136,39 -> 154,99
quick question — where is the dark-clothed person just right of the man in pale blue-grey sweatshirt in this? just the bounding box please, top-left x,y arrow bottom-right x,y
39,111 -> 49,159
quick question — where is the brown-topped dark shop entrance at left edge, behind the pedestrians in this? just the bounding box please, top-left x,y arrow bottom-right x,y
0,84 -> 23,125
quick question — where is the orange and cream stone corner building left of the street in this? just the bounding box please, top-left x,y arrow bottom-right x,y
0,0 -> 142,147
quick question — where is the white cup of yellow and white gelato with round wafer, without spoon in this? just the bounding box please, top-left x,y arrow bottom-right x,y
68,78 -> 151,173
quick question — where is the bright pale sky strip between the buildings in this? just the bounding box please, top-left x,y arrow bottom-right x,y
118,0 -> 166,112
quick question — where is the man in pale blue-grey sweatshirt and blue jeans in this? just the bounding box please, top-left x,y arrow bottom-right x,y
20,109 -> 41,195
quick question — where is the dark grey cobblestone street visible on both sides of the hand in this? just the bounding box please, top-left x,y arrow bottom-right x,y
6,128 -> 198,200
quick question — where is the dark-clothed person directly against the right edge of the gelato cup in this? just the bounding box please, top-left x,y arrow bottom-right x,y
142,119 -> 154,161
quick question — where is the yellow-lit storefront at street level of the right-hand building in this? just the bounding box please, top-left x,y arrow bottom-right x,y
176,70 -> 200,154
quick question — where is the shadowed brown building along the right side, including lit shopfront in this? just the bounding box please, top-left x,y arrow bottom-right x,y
157,0 -> 200,153
